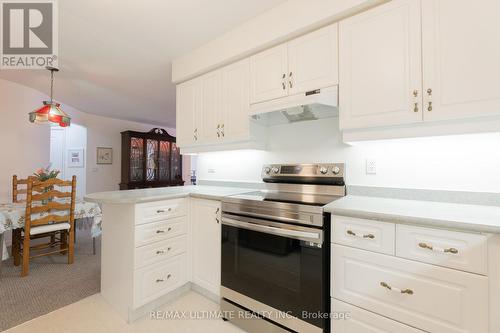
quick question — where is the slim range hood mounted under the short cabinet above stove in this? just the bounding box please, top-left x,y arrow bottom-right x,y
250,86 -> 339,126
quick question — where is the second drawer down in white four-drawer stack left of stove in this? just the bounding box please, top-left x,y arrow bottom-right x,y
135,216 -> 187,246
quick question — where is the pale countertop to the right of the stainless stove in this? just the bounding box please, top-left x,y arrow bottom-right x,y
324,195 -> 500,233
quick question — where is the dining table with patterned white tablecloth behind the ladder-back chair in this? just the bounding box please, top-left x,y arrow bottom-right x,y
0,198 -> 102,273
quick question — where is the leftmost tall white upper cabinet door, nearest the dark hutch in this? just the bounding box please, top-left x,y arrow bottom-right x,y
176,79 -> 201,147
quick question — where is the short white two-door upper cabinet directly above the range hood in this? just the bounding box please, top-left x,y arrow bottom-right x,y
250,24 -> 338,104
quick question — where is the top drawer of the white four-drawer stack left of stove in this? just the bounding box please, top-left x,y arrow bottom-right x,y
135,198 -> 187,225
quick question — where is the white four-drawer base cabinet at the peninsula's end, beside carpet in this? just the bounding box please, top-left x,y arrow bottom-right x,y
101,198 -> 190,322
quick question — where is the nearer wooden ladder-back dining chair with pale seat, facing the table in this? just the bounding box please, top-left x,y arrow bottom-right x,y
12,176 -> 76,276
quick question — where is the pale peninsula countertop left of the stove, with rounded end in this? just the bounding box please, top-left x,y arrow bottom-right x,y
85,185 -> 255,204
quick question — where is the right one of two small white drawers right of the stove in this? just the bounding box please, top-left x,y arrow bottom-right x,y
396,225 -> 488,275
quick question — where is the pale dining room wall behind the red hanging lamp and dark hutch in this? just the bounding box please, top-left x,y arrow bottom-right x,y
0,79 -> 175,202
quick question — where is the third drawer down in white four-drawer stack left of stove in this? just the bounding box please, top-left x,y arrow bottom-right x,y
135,236 -> 187,268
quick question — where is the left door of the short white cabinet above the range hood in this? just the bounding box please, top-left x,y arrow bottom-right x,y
250,44 -> 288,104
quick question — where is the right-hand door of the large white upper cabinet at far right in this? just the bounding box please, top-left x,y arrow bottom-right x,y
422,0 -> 500,120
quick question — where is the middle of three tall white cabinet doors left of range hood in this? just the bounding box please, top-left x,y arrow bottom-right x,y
199,70 -> 222,144
